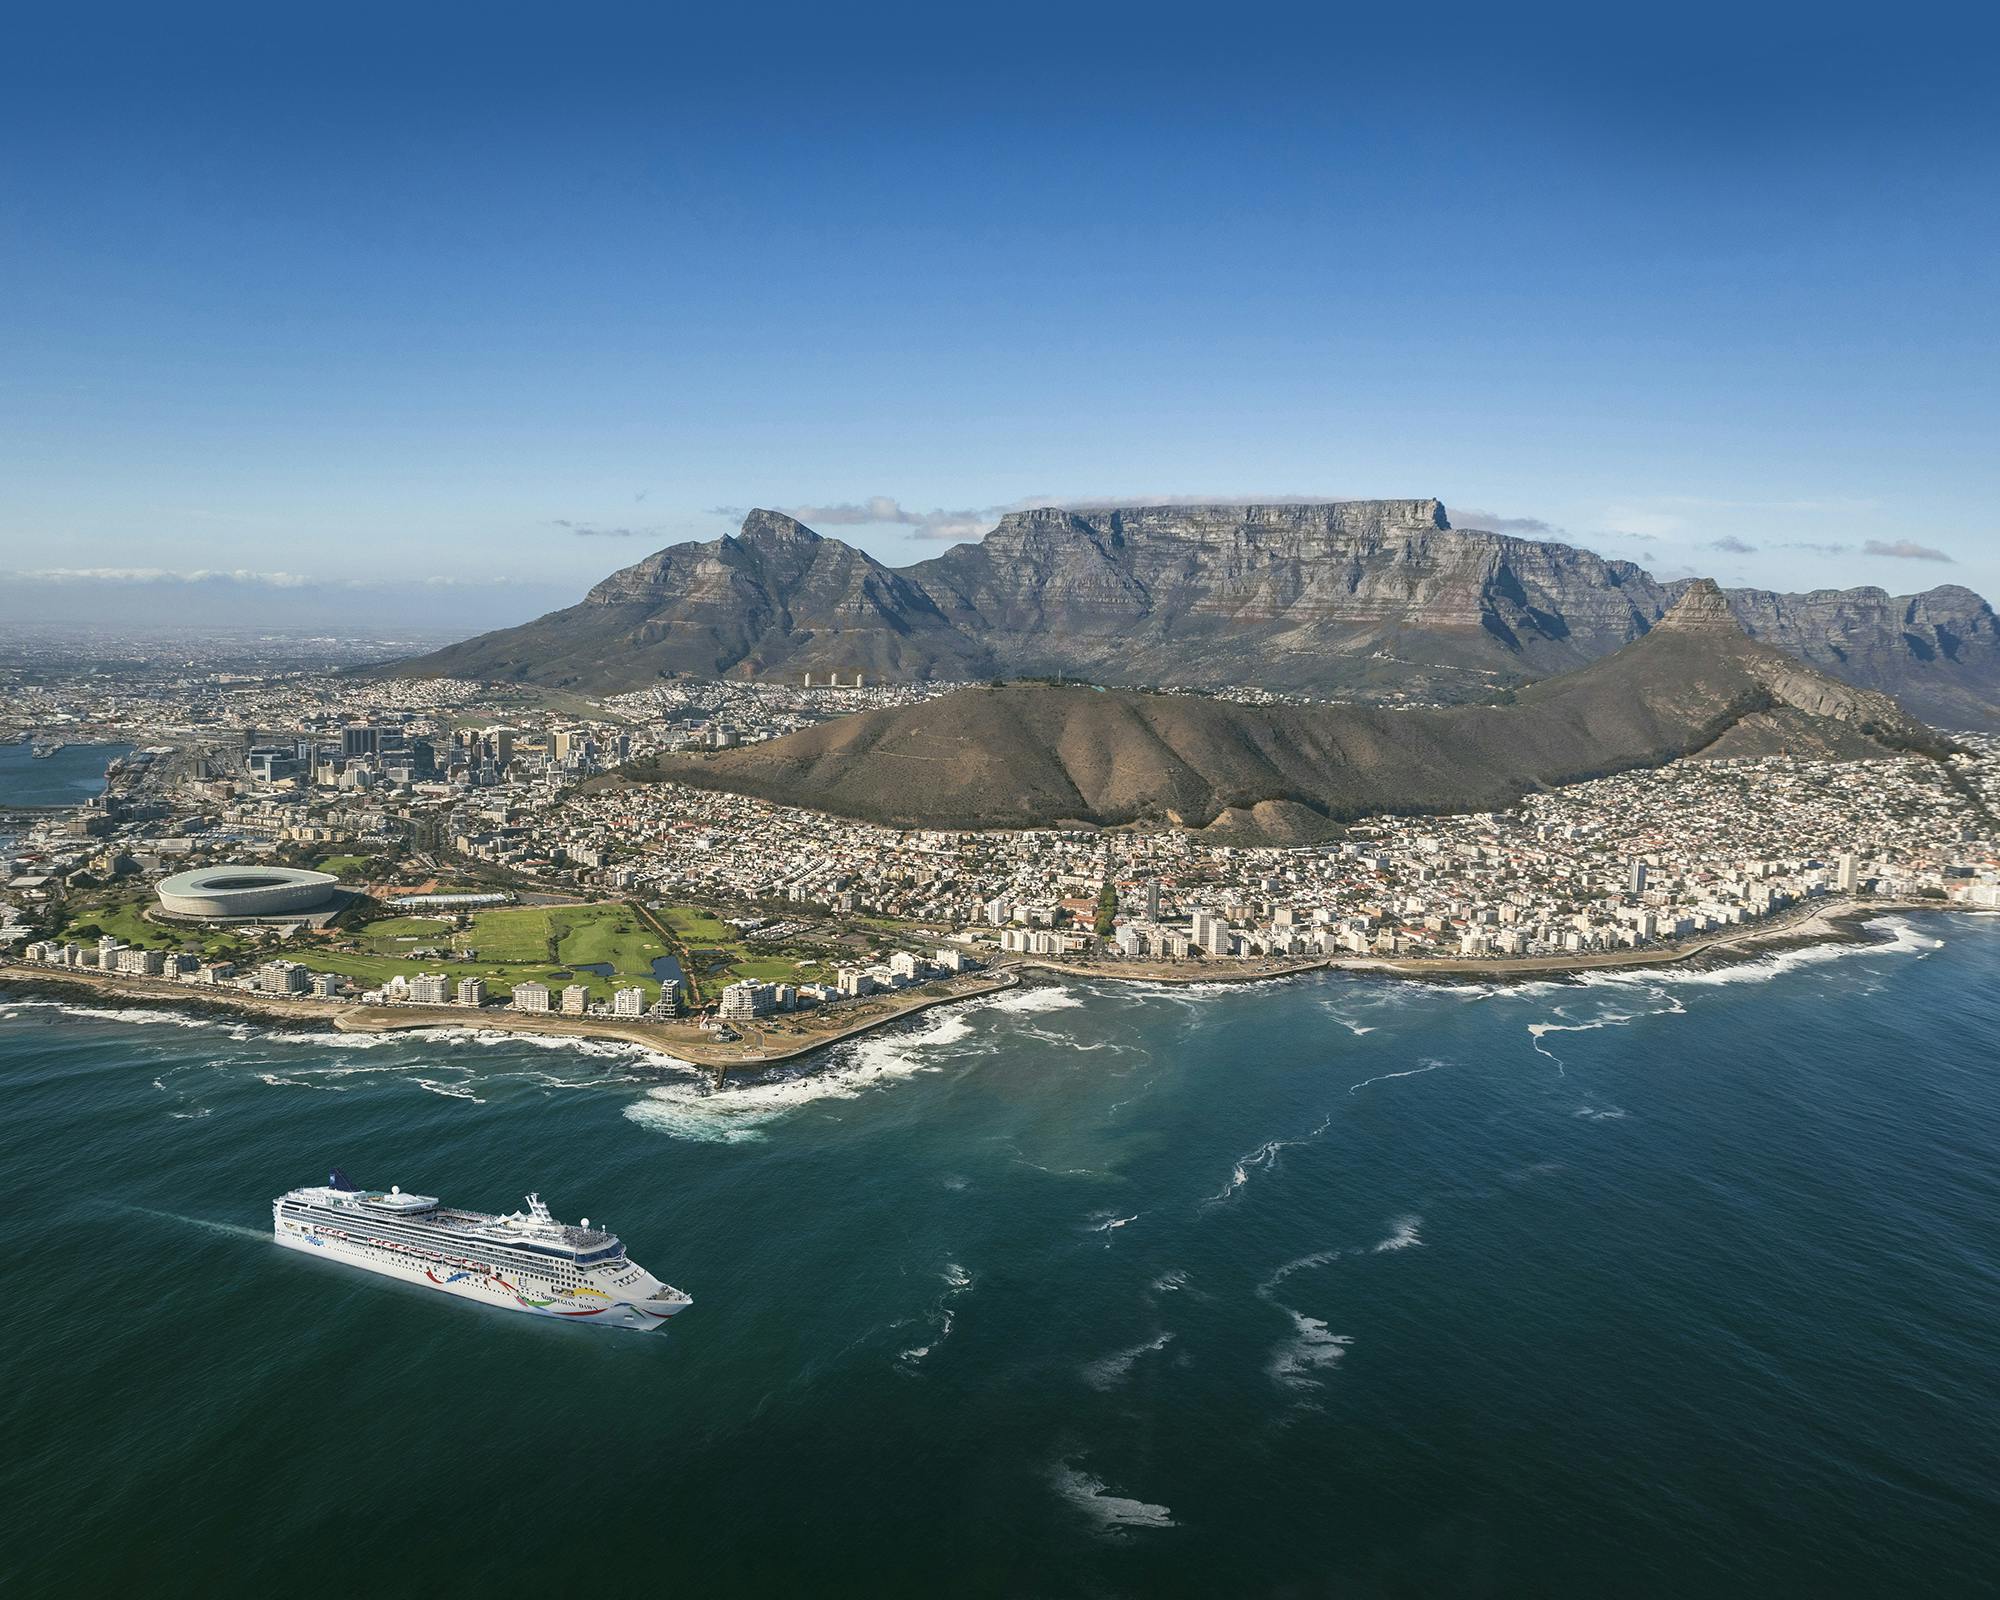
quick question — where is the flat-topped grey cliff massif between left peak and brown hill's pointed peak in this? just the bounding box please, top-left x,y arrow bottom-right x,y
910,500 -> 1668,688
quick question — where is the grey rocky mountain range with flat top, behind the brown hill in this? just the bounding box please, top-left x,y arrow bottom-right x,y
392,500 -> 2000,726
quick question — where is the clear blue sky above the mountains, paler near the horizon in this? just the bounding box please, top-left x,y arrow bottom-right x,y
0,4 -> 2000,626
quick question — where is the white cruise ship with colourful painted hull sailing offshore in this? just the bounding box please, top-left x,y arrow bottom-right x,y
270,1166 -> 694,1332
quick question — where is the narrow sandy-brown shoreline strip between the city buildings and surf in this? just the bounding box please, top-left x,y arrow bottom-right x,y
0,898 -> 1952,1084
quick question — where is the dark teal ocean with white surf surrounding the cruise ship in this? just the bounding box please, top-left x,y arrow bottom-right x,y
0,916 -> 2000,1596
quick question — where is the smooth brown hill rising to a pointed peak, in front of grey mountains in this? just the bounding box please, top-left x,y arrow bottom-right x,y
622,578 -> 1950,844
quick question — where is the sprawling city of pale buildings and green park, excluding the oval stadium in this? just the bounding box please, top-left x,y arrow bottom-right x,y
0,656 -> 2000,1046
